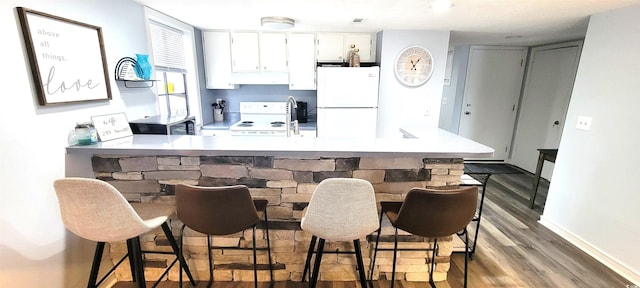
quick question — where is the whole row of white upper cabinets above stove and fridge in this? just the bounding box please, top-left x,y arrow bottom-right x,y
202,30 -> 375,90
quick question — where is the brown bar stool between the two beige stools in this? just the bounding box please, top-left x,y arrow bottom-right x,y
176,184 -> 273,287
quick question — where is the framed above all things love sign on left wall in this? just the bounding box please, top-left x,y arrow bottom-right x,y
17,7 -> 111,105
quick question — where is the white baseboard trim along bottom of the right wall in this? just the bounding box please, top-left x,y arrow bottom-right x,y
538,216 -> 640,286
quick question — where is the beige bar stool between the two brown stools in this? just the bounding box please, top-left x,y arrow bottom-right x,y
300,178 -> 379,288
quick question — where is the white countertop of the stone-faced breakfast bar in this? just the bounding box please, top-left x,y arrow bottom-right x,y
67,128 -> 494,158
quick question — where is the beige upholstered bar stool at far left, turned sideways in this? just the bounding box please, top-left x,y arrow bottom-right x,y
53,178 -> 195,287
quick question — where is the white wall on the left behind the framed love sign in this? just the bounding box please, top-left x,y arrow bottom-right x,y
0,0 -> 157,288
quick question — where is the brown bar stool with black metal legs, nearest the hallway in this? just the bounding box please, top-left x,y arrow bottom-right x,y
371,186 -> 478,288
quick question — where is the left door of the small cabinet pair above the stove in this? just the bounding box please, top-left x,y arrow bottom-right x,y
231,32 -> 260,72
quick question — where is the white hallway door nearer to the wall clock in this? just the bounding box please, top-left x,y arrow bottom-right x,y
458,46 -> 527,161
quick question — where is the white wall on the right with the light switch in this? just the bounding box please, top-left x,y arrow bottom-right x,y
541,6 -> 640,284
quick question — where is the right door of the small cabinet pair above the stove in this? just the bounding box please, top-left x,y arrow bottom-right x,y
260,33 -> 287,72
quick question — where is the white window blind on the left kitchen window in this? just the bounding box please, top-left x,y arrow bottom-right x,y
149,20 -> 187,73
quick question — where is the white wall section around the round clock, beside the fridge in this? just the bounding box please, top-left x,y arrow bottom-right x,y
376,30 -> 449,138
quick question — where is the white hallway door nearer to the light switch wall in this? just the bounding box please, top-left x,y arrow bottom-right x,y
510,42 -> 582,179
